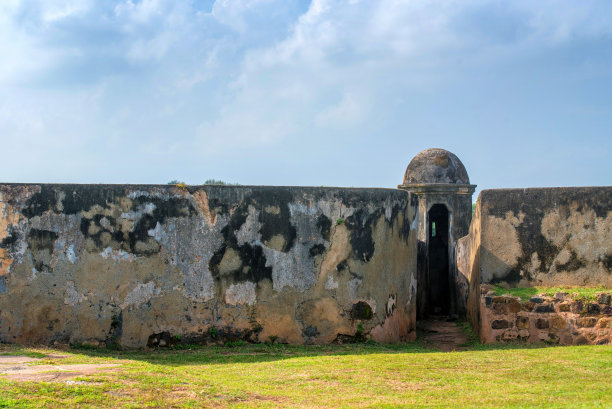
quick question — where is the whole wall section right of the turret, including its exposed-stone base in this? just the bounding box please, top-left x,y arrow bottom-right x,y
457,187 -> 612,344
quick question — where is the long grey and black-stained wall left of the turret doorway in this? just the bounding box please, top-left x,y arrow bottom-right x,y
0,184 -> 417,347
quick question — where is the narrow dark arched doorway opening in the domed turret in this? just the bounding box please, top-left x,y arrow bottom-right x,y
425,204 -> 451,315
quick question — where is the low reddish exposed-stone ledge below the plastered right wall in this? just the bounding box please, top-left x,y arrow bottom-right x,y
480,285 -> 612,345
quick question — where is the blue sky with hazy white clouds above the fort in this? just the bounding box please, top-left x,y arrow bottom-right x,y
0,0 -> 612,192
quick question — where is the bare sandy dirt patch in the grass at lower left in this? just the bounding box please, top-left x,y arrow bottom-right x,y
0,355 -> 120,382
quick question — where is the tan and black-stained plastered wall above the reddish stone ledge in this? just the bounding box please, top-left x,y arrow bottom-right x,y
464,187 -> 612,341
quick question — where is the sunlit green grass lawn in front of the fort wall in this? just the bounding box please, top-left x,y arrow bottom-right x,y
0,343 -> 612,408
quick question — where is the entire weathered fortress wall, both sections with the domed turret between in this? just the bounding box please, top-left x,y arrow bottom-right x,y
0,149 -> 612,347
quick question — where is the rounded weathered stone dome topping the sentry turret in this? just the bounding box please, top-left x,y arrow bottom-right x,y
403,148 -> 470,185
